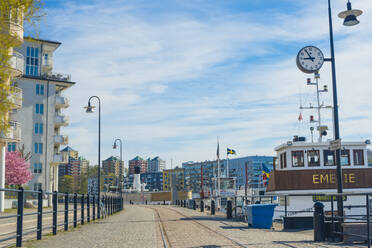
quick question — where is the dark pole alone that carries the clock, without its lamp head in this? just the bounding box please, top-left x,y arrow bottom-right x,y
328,0 -> 344,220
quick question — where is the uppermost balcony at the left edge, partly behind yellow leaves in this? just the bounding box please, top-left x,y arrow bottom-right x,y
0,11 -> 23,44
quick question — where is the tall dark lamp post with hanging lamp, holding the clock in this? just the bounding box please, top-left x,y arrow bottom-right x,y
325,0 -> 363,217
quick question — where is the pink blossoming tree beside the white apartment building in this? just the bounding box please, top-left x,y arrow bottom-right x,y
5,151 -> 32,185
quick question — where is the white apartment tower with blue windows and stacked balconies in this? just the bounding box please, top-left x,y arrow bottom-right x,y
12,37 -> 75,194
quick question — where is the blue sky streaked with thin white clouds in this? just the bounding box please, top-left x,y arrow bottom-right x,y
33,0 -> 372,168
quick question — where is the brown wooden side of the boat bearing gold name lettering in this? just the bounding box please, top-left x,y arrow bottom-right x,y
266,168 -> 372,192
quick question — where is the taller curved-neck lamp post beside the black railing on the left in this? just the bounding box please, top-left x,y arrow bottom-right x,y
85,96 -> 101,219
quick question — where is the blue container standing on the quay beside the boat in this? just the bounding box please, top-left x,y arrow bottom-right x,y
247,204 -> 277,229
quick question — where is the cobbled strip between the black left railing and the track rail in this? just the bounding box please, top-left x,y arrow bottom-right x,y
25,205 -> 161,248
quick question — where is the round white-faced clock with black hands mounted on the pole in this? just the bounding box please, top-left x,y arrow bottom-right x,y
296,46 -> 324,74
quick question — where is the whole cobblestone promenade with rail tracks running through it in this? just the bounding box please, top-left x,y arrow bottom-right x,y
26,205 -> 365,248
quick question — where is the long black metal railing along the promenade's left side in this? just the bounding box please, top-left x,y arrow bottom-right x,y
0,188 -> 124,247
